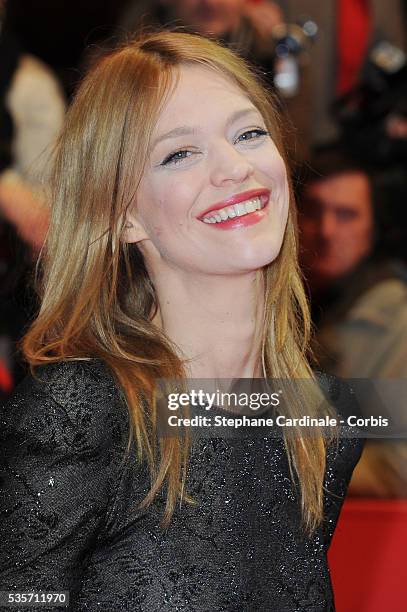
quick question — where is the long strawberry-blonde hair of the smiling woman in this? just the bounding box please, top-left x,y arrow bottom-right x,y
22,32 -> 338,532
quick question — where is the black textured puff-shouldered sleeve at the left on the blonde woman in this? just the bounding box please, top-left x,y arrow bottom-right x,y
0,362 -> 130,602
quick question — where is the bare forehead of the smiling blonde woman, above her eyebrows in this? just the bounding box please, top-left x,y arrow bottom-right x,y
155,65 -> 258,132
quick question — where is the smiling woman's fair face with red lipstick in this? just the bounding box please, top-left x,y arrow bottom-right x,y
127,65 -> 289,275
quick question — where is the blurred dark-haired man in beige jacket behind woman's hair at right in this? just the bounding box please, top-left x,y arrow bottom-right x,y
299,150 -> 407,497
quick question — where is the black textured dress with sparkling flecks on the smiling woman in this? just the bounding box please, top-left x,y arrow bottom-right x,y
0,361 -> 362,612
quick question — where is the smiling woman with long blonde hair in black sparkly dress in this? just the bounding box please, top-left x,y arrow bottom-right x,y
0,33 -> 361,612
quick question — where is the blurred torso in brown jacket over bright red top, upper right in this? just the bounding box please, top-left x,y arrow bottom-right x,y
276,0 -> 407,149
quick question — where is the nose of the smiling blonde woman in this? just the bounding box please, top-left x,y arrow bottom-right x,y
211,143 -> 254,187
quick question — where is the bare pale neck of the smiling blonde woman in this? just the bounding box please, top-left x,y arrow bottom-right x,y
153,270 -> 264,378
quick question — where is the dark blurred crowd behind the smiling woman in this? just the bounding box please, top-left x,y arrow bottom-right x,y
0,0 -> 407,498
